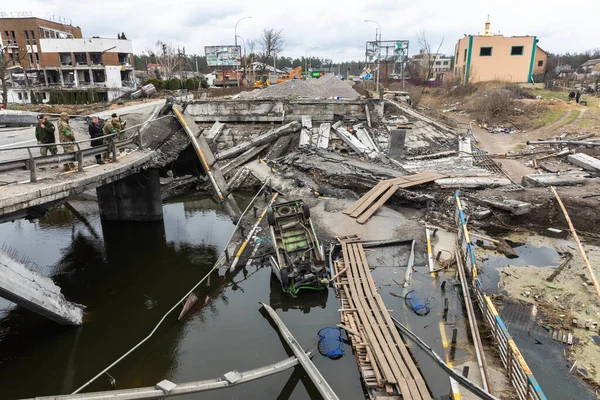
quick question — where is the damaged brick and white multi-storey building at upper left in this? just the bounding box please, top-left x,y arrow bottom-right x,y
0,13 -> 137,104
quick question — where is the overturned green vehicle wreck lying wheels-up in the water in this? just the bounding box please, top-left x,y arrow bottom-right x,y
267,200 -> 329,295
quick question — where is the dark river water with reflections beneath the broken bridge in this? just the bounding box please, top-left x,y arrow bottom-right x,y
0,195 -> 364,399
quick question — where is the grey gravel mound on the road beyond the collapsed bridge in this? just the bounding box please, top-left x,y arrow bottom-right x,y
238,75 -> 360,99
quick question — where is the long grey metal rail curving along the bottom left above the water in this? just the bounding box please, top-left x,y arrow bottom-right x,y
30,352 -> 311,400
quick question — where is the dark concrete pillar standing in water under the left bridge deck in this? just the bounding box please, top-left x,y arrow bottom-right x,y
96,168 -> 163,221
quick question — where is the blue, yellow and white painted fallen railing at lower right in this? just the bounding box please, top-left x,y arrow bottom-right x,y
455,191 -> 546,400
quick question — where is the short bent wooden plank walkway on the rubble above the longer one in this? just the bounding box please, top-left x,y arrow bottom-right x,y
343,171 -> 446,224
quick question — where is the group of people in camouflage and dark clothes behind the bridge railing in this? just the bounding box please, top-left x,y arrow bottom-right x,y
35,112 -> 126,171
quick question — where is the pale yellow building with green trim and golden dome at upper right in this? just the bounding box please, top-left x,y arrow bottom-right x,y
454,21 -> 548,83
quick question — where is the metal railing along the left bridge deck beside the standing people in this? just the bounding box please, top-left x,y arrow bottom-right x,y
0,115 -> 173,183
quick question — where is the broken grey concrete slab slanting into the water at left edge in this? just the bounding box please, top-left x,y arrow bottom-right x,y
0,252 -> 83,325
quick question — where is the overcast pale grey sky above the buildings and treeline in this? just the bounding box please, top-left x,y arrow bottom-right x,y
0,0 -> 600,62
